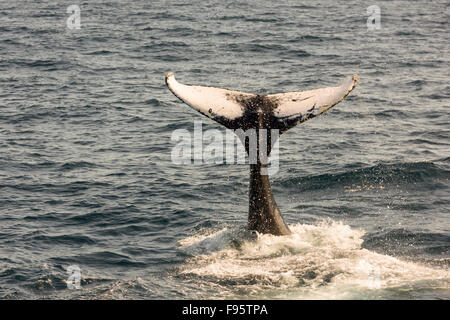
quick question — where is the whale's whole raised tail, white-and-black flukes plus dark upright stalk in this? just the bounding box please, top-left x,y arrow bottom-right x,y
166,72 -> 359,235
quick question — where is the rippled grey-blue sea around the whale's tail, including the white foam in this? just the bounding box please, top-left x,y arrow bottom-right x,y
0,0 -> 450,299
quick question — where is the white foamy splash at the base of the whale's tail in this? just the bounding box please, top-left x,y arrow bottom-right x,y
180,221 -> 450,299
